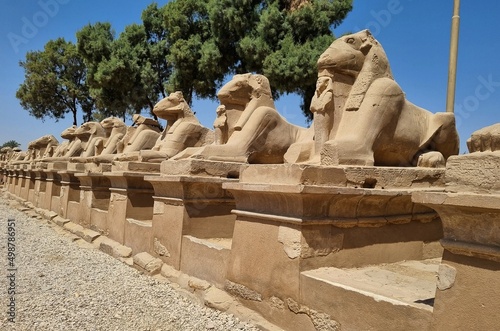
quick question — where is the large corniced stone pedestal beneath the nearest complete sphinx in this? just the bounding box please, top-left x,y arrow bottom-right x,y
223,165 -> 444,325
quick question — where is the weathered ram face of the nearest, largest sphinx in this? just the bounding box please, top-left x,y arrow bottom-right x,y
318,30 -> 377,75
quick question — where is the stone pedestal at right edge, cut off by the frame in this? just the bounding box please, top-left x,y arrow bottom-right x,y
413,152 -> 500,330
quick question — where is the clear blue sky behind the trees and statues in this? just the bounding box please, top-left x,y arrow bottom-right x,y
0,0 -> 500,153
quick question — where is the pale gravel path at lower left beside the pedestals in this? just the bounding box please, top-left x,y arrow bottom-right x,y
0,197 -> 257,331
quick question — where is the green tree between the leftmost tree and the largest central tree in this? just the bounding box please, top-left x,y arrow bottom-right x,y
77,8 -> 171,118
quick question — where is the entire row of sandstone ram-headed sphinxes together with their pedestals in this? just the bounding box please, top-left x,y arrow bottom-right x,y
0,31 -> 500,331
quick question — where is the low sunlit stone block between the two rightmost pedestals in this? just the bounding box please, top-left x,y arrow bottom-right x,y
300,260 -> 439,331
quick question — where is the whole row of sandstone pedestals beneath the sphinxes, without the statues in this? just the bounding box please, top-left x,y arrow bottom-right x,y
3,153 -> 500,330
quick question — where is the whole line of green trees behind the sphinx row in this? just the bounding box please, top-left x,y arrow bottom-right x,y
17,0 -> 352,124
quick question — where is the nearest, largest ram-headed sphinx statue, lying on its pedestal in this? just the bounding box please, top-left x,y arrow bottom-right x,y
313,30 -> 459,166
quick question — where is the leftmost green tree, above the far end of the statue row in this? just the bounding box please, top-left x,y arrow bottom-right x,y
16,38 -> 94,125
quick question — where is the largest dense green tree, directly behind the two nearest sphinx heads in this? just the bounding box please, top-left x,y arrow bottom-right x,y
165,0 -> 352,118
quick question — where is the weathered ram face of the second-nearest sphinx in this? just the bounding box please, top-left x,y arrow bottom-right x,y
217,73 -> 271,105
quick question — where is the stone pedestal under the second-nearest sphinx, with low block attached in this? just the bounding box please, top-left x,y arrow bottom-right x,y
146,160 -> 241,286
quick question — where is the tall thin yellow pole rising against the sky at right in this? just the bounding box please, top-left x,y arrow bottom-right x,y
446,0 -> 460,113
